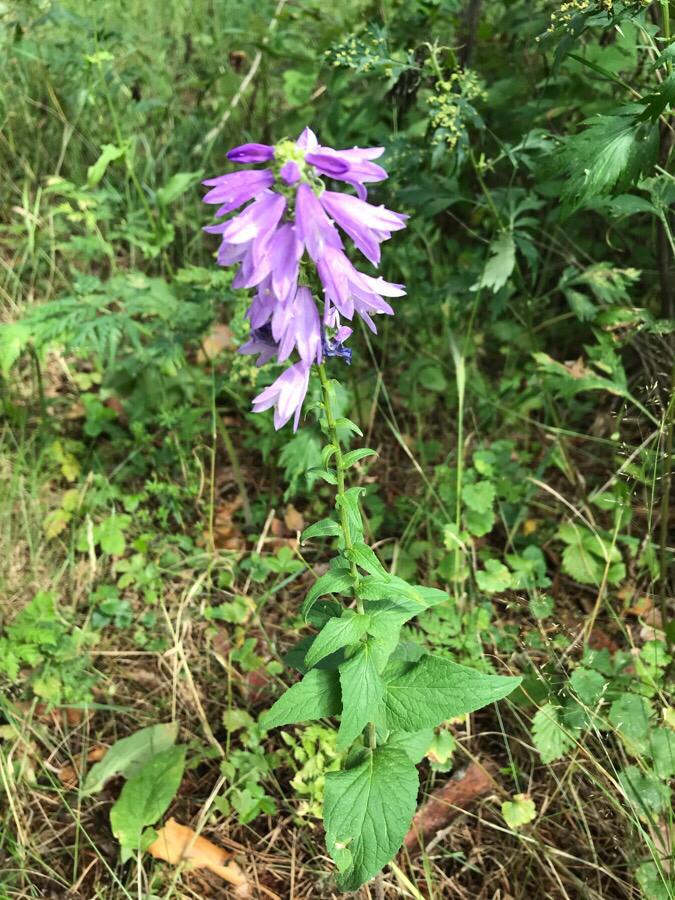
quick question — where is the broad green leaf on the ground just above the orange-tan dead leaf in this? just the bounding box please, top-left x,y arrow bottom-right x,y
110,746 -> 186,858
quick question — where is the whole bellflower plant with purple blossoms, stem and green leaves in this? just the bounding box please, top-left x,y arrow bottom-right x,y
204,128 -> 520,891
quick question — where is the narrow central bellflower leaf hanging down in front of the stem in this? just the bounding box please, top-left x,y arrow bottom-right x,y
337,644 -> 386,750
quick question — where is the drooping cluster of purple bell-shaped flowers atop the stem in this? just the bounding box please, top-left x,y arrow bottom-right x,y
204,128 -> 407,429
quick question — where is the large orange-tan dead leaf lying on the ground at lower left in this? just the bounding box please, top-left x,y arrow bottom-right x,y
148,819 -> 251,897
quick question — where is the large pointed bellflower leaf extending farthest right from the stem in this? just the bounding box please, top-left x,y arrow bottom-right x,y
385,656 -> 522,731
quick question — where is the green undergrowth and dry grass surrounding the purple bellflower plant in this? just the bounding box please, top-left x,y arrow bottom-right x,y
0,0 -> 675,900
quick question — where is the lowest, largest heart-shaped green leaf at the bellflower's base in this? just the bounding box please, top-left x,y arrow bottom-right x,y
323,746 -> 419,891
